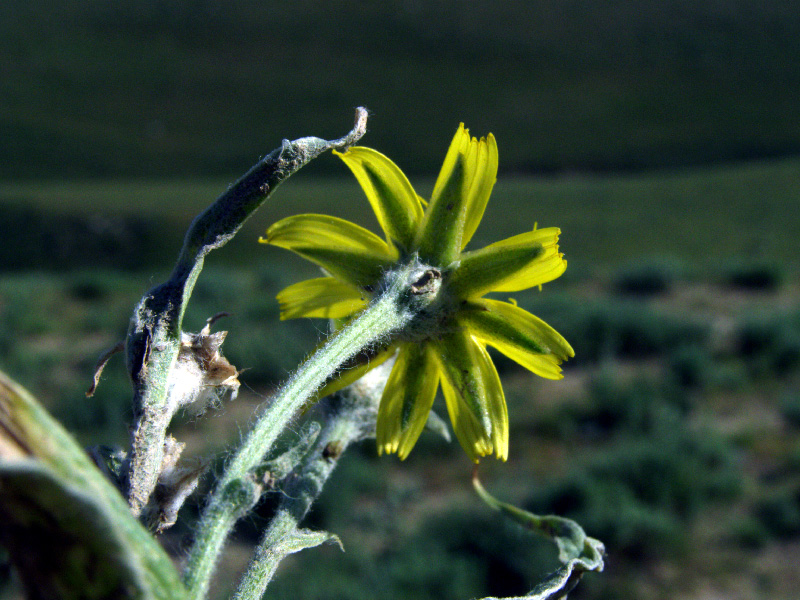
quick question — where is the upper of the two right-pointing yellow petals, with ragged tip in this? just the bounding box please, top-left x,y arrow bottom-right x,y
449,227 -> 567,298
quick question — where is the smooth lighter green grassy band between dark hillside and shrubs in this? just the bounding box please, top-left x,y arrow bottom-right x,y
0,159 -> 800,272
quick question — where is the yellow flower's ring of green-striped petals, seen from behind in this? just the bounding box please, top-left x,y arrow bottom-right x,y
259,124 -> 574,462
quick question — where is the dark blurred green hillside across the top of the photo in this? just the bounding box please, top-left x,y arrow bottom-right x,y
0,0 -> 800,178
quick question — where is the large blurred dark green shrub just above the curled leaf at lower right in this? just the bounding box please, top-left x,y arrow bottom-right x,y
527,423 -> 741,557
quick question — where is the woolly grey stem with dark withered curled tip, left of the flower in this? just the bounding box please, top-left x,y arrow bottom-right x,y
125,108 -> 367,515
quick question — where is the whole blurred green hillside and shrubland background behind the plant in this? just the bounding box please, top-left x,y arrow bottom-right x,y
0,0 -> 800,600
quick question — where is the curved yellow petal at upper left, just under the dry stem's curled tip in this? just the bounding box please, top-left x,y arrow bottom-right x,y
333,147 -> 422,250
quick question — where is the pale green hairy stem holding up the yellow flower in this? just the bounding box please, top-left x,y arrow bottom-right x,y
184,261 -> 438,600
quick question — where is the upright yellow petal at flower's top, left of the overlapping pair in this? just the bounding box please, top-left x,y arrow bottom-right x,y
415,123 -> 486,267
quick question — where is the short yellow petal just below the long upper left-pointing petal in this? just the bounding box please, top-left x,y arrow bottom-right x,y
278,277 -> 367,321
